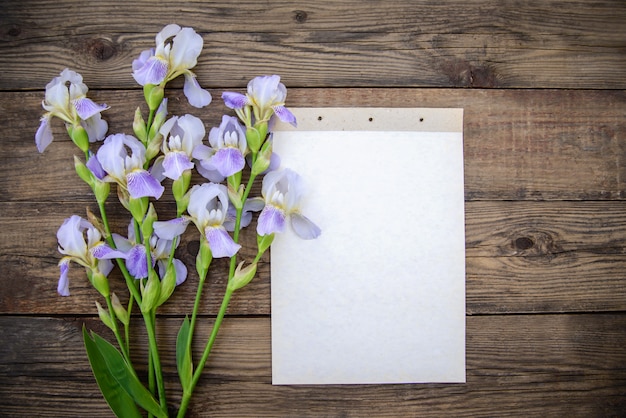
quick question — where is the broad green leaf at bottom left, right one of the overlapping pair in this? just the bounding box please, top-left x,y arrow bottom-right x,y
83,327 -> 167,418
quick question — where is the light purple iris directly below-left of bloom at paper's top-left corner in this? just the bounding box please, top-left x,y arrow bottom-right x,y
193,115 -> 247,182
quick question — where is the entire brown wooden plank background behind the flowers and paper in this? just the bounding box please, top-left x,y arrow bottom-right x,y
0,0 -> 626,417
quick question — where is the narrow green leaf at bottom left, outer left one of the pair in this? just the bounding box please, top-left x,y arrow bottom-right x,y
83,327 -> 141,418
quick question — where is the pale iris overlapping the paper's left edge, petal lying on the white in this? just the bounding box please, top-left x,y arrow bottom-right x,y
257,169 -> 321,239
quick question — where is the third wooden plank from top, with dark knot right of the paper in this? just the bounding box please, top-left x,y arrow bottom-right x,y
0,201 -> 626,315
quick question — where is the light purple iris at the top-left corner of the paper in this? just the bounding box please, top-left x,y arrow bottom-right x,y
222,75 -> 296,126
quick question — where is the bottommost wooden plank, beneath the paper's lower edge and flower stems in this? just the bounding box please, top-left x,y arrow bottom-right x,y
0,314 -> 626,417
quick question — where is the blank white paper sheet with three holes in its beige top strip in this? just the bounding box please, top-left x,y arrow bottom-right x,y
271,108 -> 465,385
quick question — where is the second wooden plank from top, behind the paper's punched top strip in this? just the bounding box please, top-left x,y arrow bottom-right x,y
0,89 -> 626,202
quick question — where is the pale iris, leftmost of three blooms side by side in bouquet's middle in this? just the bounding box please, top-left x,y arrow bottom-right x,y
96,134 -> 165,199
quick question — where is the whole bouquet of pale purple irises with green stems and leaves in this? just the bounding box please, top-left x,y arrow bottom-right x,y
35,24 -> 320,417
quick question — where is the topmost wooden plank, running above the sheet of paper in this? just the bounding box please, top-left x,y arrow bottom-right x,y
0,0 -> 626,90
